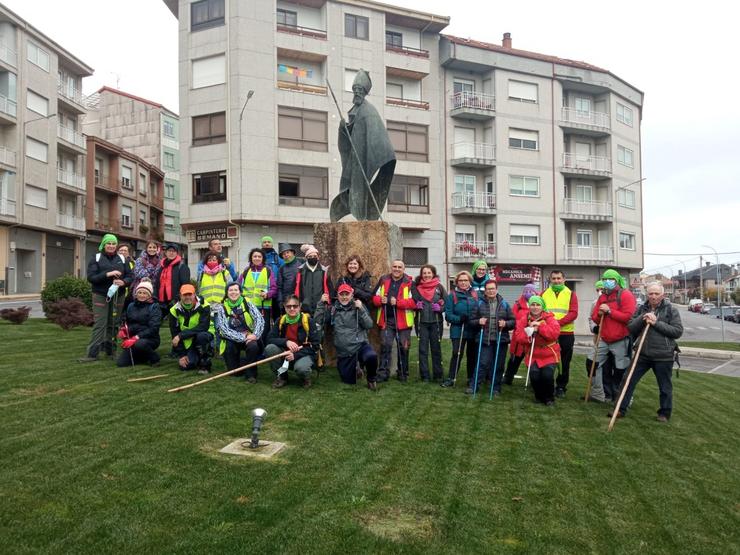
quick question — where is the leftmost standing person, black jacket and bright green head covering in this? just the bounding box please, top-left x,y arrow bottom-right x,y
78,233 -> 134,362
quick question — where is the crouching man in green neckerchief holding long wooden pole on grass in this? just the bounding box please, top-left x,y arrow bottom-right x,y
265,295 -> 322,389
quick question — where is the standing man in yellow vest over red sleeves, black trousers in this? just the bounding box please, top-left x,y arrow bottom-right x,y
540,270 -> 578,397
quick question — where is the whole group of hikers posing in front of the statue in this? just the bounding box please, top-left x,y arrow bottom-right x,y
80,234 -> 683,422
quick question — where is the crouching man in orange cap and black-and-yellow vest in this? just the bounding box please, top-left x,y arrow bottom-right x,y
170,283 -> 213,374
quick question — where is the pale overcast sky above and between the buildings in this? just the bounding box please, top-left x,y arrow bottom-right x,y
0,0 -> 740,273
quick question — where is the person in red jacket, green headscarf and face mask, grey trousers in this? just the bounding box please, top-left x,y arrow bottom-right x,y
591,269 -> 637,403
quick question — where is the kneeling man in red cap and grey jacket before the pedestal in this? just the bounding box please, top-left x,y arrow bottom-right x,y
314,283 -> 378,391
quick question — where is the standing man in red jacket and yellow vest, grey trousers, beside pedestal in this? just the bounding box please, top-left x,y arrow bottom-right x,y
373,260 -> 416,382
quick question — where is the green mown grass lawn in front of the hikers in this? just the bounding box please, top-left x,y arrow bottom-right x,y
0,320 -> 740,554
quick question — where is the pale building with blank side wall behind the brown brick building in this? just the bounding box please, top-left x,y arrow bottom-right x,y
83,87 -> 183,250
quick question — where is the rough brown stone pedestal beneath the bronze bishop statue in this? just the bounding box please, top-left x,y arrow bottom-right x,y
313,221 -> 403,374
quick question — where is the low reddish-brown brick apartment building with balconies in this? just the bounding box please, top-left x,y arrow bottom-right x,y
85,135 -> 164,253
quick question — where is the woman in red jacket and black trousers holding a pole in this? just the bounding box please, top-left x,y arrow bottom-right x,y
514,295 -> 560,406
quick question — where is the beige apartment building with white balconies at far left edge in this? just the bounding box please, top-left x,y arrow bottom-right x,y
0,4 -> 93,294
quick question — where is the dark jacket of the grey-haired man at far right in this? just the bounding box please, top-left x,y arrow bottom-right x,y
627,299 -> 683,361
